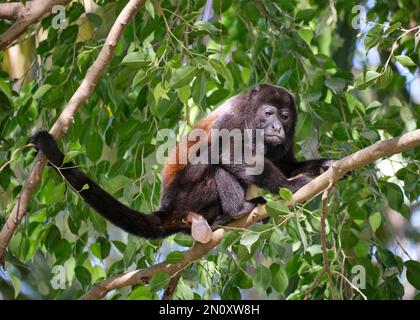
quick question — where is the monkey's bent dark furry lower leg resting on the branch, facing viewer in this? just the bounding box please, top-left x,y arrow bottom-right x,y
215,168 -> 256,219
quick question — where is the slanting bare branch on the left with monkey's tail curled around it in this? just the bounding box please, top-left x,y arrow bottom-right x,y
0,0 -> 145,267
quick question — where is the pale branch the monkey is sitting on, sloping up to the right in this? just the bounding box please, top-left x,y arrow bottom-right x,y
82,129 -> 420,300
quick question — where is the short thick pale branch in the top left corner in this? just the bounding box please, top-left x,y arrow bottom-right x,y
0,0 -> 71,50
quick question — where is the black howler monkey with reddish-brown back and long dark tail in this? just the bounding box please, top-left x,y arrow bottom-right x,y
32,84 -> 332,239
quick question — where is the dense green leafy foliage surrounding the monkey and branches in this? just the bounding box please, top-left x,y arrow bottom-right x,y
0,0 -> 420,299
